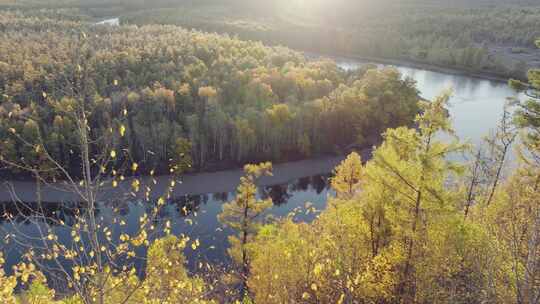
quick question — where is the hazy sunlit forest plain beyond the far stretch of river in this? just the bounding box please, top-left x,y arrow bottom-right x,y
121,1 -> 540,78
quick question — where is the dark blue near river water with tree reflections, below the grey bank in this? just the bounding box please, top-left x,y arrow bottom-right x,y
0,175 -> 331,273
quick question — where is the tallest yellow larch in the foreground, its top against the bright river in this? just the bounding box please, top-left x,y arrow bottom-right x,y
365,93 -> 464,303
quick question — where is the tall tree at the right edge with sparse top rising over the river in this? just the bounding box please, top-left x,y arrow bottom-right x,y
496,40 -> 540,304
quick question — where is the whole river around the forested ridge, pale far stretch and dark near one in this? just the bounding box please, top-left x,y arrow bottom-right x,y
0,58 -> 518,270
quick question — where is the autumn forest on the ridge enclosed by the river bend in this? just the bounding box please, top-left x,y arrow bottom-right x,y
0,13 -> 419,177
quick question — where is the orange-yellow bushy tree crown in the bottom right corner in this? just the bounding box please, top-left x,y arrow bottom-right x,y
488,165 -> 540,304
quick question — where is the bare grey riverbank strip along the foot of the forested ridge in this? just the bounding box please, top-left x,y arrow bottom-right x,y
0,149 -> 371,203
